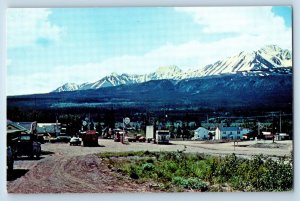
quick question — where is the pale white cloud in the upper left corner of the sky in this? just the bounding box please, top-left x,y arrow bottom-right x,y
7,8 -> 62,48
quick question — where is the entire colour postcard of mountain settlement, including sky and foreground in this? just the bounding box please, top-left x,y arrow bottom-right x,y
6,6 -> 293,194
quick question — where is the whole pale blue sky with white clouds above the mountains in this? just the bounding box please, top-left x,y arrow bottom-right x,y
6,6 -> 292,95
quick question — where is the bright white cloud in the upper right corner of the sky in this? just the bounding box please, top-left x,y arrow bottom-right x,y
175,6 -> 292,50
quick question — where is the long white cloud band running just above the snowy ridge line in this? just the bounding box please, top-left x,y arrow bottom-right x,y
8,35 -> 292,95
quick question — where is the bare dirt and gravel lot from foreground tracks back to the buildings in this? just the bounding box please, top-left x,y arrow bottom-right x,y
7,139 -> 292,193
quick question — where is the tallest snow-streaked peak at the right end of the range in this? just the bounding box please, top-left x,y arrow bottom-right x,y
185,45 -> 292,78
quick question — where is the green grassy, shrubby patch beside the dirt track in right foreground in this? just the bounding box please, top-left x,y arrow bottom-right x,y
98,151 -> 293,192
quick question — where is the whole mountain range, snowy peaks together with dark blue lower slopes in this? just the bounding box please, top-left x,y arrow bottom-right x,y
7,45 -> 293,111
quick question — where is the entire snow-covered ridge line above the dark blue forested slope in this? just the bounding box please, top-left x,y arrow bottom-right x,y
53,45 -> 292,92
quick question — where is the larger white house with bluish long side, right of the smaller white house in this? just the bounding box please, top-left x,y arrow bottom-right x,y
214,127 -> 251,140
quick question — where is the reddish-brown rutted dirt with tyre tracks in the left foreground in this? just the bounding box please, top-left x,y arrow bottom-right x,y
7,155 -> 157,193
